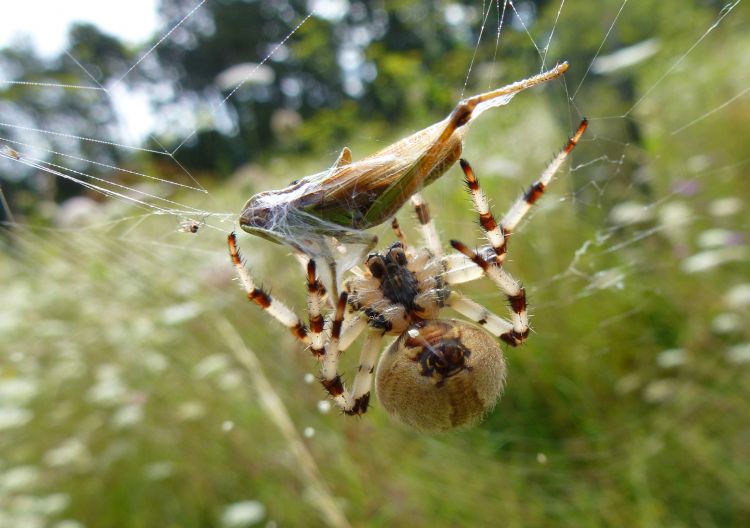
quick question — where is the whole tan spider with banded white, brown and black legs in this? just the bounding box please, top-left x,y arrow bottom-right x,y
228,119 -> 587,432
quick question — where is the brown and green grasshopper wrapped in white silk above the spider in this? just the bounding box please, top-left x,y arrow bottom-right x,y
239,62 -> 568,292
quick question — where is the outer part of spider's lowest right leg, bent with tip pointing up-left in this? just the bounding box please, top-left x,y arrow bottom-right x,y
451,240 -> 529,346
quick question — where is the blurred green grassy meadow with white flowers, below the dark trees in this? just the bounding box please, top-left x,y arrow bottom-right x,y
0,2 -> 750,528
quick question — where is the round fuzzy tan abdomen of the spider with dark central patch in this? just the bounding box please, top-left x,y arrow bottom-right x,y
376,320 -> 506,431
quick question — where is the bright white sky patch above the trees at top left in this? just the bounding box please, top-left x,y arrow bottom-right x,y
0,0 -> 157,56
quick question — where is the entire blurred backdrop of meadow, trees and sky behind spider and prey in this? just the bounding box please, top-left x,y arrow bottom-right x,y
0,0 -> 750,528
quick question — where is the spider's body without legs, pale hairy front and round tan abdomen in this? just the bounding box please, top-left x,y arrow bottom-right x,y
345,242 -> 505,431
